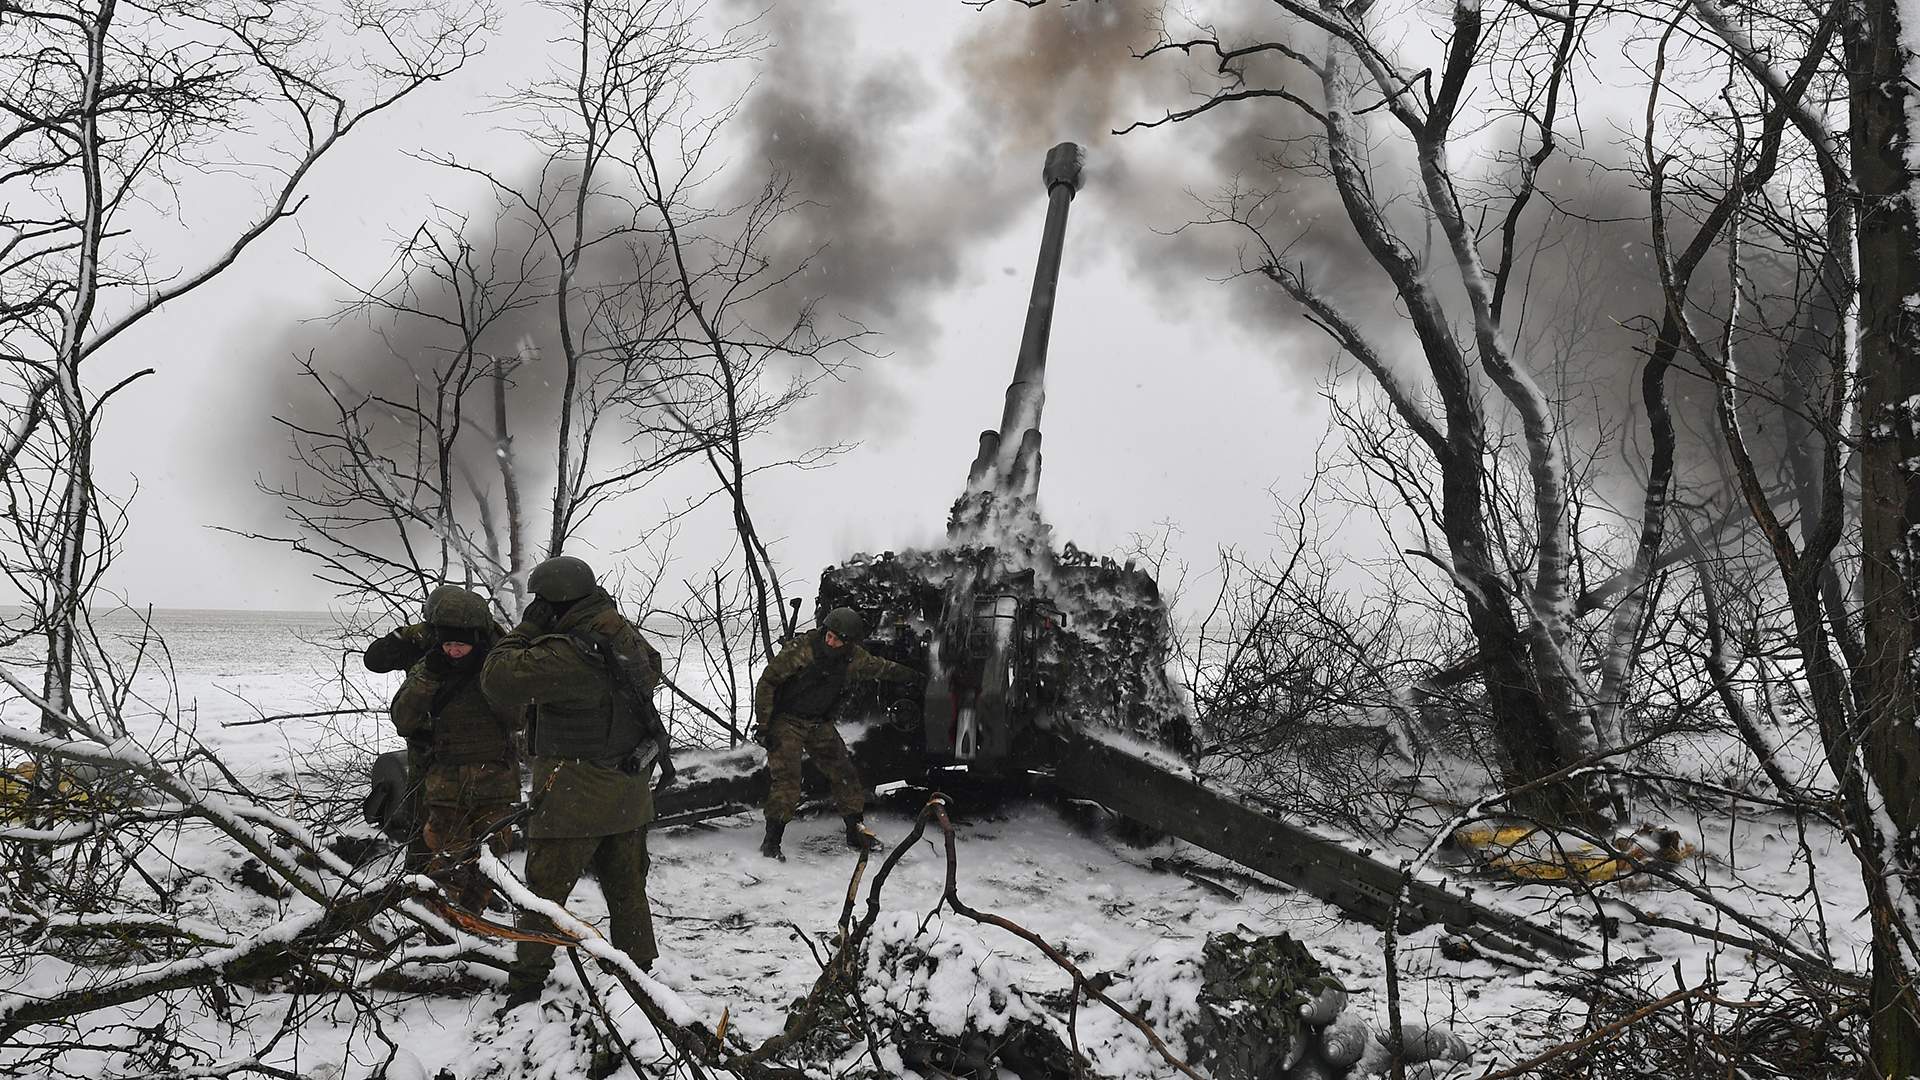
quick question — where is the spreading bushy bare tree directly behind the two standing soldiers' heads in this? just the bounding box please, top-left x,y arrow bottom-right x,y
251,200 -> 676,621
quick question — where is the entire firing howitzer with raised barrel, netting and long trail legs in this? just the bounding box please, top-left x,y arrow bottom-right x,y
360,142 -> 1588,963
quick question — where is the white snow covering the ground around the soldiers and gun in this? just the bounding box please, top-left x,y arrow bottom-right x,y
0,621 -> 1868,1080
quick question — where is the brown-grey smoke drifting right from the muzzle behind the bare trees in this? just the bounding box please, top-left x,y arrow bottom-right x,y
929,2 -> 1843,526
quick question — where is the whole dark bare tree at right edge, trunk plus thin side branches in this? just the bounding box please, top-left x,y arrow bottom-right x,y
1688,0 -> 1920,1076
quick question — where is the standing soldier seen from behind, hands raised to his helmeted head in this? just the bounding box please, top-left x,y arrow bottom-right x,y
480,555 -> 674,1009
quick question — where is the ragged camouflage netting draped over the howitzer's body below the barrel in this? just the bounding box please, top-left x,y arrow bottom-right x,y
818,544 -> 1192,755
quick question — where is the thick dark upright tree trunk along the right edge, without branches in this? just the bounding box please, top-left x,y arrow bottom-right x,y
1843,0 -> 1920,1076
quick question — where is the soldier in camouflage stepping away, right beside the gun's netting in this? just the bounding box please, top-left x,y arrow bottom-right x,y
753,607 -> 925,861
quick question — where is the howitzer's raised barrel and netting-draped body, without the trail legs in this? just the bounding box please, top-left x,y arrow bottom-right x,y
820,142 -> 1190,764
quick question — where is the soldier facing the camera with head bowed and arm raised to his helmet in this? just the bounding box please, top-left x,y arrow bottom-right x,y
363,584 -> 520,895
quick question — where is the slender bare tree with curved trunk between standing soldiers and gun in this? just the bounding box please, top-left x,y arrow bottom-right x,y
524,0 -> 866,657
